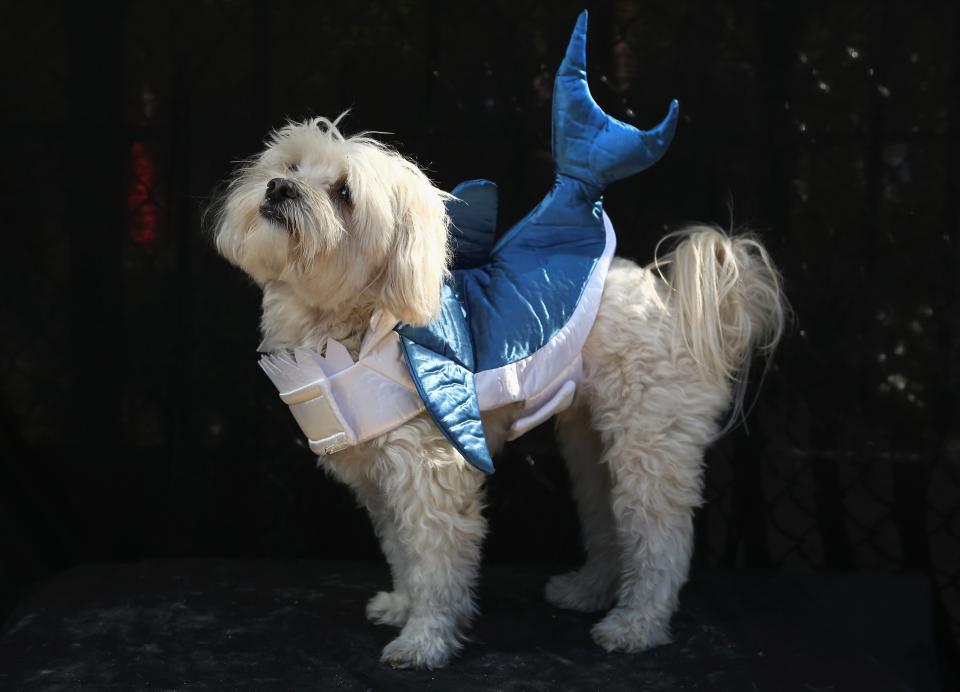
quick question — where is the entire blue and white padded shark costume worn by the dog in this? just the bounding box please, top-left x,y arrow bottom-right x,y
260,12 -> 678,473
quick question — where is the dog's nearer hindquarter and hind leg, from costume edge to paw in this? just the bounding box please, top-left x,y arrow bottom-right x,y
582,260 -> 730,651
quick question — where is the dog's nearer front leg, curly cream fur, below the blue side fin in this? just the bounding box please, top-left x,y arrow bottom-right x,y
381,443 -> 486,668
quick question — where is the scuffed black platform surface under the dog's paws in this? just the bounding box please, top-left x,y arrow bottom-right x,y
0,560 -> 936,692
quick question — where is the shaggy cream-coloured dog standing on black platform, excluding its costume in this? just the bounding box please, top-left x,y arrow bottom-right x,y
215,112 -> 783,668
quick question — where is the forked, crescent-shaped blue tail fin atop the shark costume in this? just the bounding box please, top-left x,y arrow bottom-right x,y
553,10 -> 680,190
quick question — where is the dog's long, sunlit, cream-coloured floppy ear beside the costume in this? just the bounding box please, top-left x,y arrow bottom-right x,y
380,161 -> 450,325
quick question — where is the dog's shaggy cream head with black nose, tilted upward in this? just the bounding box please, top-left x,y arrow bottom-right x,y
215,118 -> 448,324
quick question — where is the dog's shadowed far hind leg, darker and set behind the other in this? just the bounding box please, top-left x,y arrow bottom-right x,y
545,406 -> 620,613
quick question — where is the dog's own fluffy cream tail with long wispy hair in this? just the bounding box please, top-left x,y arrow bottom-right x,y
655,226 -> 787,427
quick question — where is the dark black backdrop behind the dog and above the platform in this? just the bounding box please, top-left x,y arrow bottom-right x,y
0,0 -> 960,680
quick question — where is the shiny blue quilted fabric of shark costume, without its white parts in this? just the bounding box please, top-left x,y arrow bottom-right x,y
396,12 -> 678,473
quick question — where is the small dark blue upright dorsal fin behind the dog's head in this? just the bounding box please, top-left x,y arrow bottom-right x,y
447,180 -> 497,269
